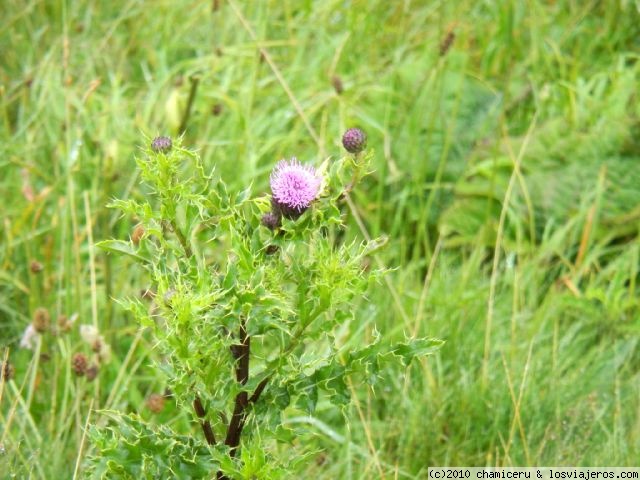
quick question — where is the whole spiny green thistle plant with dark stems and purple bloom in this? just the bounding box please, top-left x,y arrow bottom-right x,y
89,130 -> 440,479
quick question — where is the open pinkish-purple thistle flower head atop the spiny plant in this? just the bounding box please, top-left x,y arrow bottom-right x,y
271,157 -> 322,220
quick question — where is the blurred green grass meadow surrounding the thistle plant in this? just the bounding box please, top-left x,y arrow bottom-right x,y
0,0 -> 640,479
